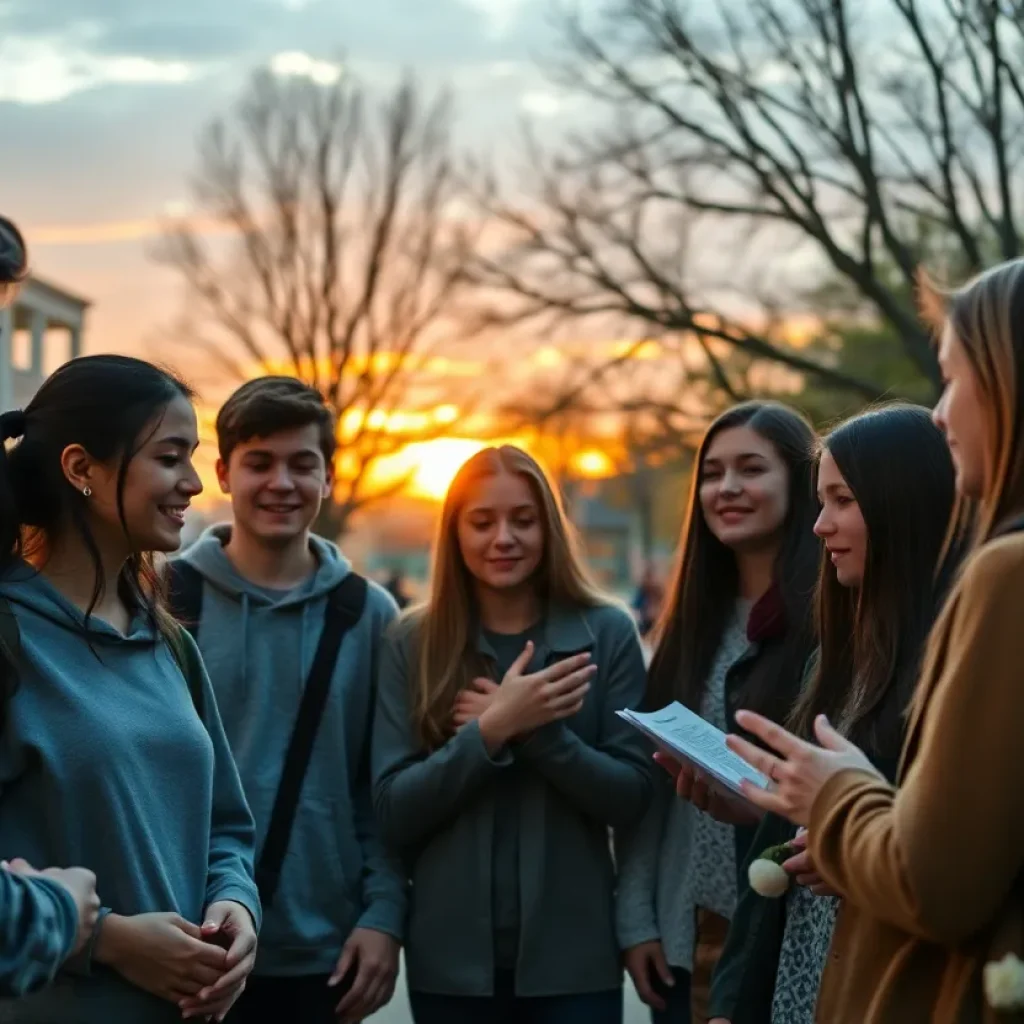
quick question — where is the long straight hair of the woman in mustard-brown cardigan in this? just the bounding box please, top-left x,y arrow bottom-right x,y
920,259 -> 1024,544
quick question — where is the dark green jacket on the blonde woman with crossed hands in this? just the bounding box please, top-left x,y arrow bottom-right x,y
373,605 -> 654,996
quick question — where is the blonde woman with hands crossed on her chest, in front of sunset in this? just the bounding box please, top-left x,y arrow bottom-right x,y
373,446 -> 652,1024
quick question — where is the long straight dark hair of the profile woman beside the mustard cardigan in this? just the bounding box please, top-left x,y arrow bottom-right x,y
791,404 -> 956,758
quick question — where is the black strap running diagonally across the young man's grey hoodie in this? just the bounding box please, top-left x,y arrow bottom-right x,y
256,572 -> 368,907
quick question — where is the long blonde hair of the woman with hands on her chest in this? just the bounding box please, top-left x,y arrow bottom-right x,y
413,444 -> 611,751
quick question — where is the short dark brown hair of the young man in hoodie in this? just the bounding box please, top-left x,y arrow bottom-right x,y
217,377 -> 338,469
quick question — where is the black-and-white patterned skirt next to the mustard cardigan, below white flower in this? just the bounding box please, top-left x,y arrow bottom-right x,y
771,886 -> 839,1024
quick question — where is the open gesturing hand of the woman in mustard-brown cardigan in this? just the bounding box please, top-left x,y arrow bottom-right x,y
726,711 -> 884,825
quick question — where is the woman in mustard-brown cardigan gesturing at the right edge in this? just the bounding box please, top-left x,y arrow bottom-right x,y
729,260 -> 1024,1024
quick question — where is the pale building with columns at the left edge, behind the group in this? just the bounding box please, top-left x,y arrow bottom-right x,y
0,278 -> 89,411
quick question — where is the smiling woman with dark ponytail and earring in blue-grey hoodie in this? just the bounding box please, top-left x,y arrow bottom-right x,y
0,355 -> 260,1024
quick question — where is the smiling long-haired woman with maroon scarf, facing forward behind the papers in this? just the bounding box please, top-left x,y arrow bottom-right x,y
616,402 -> 817,1024
